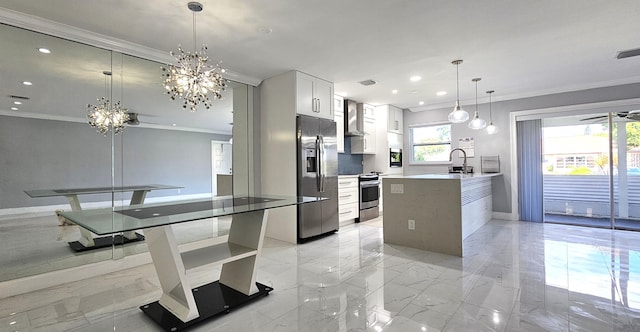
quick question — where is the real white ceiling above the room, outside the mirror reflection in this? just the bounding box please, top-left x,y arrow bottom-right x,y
0,0 -> 640,111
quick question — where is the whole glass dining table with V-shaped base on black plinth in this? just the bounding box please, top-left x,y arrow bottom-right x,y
62,195 -> 326,331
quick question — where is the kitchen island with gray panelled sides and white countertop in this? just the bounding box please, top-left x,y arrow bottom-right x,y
382,173 -> 502,257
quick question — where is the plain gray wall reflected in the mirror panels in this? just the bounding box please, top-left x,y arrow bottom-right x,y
0,116 -> 230,209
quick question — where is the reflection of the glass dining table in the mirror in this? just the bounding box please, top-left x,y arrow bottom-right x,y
25,184 -> 182,251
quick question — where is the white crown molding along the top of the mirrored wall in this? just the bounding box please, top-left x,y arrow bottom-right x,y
0,7 -> 262,86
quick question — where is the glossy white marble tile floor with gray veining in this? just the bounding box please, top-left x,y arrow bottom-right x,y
0,220 -> 640,332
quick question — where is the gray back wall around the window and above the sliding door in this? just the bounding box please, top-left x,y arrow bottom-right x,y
403,83 -> 640,213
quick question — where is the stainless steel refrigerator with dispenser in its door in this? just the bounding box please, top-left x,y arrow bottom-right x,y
297,115 -> 338,242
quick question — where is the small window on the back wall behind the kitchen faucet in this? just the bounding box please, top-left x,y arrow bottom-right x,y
411,123 -> 451,163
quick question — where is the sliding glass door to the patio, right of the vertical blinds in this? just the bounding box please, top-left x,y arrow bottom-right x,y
542,112 -> 640,230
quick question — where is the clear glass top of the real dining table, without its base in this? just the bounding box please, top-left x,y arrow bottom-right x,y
61,195 -> 327,235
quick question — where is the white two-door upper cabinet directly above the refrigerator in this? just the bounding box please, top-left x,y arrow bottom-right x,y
296,72 -> 334,120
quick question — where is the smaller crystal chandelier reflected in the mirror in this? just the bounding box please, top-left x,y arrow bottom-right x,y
87,71 -> 129,136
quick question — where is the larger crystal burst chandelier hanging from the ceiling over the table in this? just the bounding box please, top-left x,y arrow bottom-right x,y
162,2 -> 227,112
